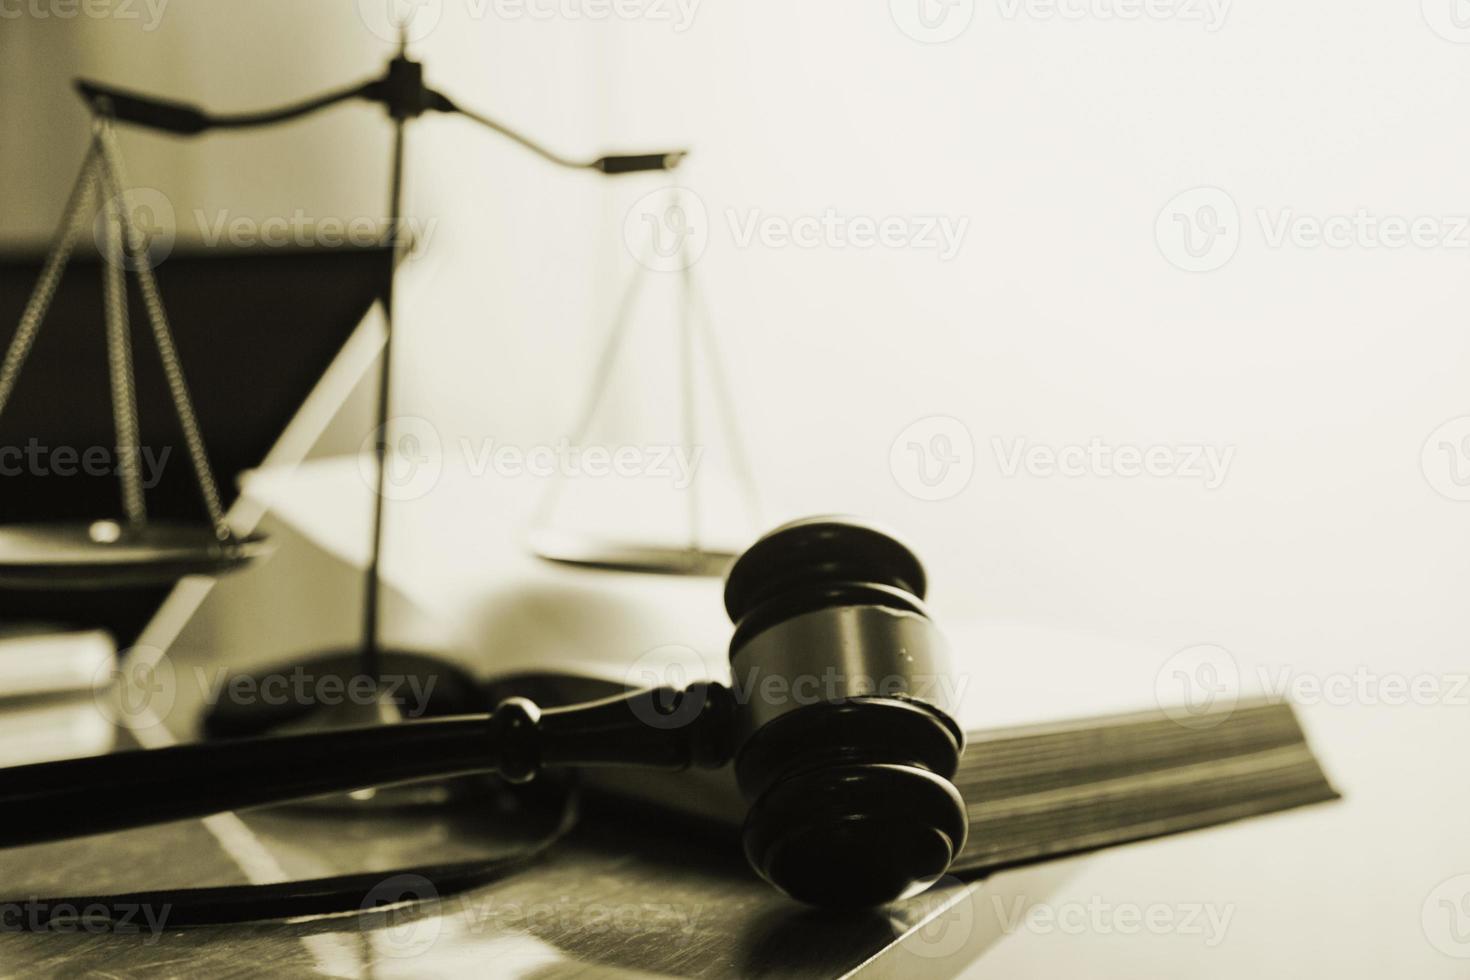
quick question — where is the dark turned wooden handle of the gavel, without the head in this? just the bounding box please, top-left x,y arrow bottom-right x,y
0,685 -> 731,846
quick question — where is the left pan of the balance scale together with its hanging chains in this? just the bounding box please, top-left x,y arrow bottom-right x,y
0,115 -> 266,591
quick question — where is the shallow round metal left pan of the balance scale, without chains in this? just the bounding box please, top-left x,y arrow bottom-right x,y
0,520 -> 268,589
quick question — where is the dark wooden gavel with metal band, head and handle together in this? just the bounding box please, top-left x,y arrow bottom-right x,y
0,517 -> 967,908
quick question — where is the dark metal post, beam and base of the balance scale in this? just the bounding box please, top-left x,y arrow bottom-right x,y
76,35 -> 685,736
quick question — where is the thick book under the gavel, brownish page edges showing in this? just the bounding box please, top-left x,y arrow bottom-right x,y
541,678 -> 1339,874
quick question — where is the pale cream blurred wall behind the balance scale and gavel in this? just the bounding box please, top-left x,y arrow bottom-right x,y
0,0 -> 1470,655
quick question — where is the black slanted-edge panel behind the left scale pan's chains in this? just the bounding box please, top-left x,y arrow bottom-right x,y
0,247 -> 392,644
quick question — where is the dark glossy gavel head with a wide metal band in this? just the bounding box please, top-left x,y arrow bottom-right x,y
725,517 -> 967,907
